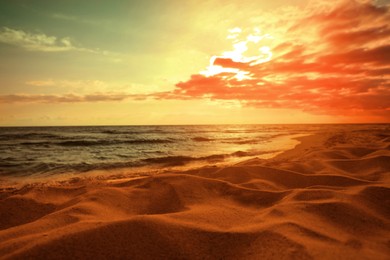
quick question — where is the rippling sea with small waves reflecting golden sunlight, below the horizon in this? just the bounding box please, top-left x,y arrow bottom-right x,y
0,125 -> 384,179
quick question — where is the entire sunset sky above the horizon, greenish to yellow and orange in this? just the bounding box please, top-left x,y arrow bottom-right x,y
0,0 -> 390,126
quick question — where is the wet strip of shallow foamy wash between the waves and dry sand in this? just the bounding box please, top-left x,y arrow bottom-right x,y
0,134 -> 315,190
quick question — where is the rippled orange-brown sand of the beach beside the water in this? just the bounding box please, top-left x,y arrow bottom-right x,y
0,131 -> 390,259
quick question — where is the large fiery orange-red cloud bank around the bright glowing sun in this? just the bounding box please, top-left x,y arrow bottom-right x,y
155,0 -> 390,120
